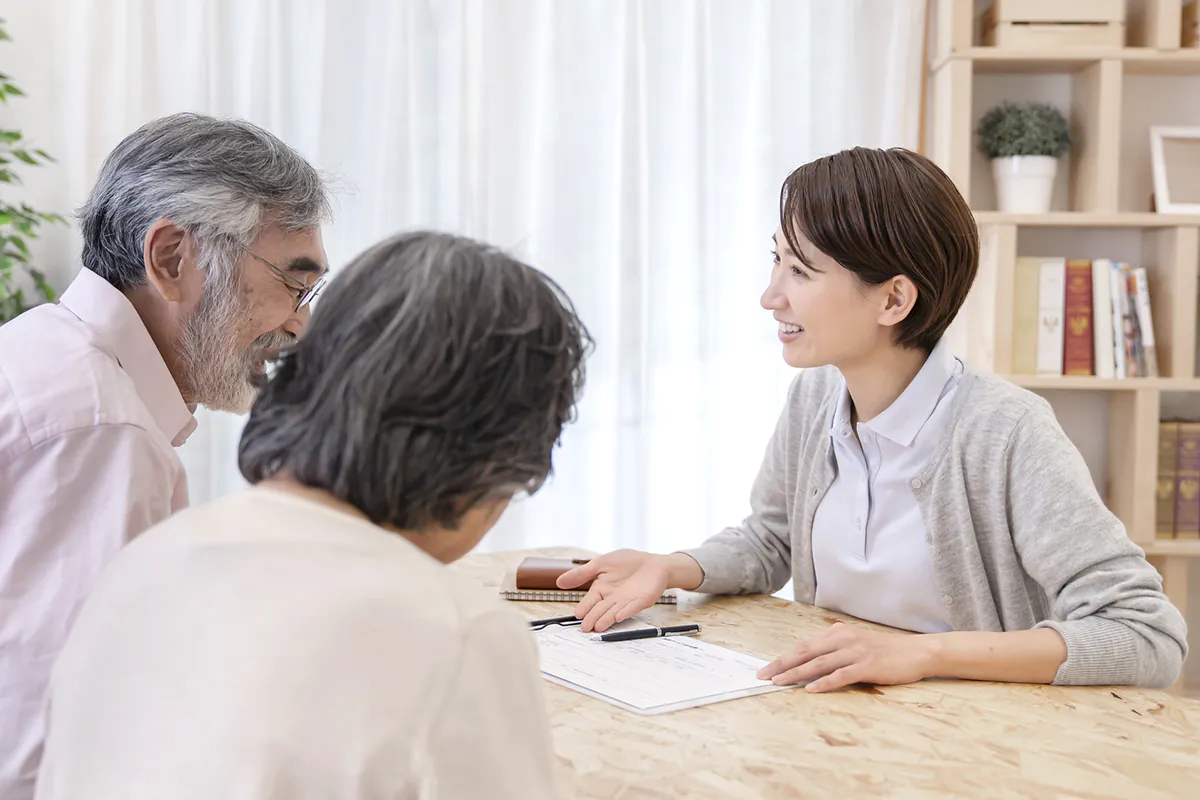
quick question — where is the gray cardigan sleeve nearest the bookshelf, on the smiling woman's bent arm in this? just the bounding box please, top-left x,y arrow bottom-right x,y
1007,405 -> 1187,687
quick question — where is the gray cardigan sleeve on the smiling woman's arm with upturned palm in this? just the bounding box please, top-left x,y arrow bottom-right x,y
682,373 -> 803,595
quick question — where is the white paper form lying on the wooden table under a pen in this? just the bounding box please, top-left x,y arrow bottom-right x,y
535,625 -> 792,714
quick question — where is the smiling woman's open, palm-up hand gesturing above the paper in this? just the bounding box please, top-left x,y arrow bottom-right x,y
558,549 -> 704,631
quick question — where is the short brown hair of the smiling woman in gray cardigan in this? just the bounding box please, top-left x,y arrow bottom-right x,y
779,148 -> 979,353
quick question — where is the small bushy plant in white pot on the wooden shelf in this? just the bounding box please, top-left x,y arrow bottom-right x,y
979,102 -> 1072,213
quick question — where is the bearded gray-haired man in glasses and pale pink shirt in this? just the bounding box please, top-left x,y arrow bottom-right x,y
0,114 -> 330,800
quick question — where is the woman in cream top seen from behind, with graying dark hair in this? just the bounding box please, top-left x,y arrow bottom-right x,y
30,233 -> 590,800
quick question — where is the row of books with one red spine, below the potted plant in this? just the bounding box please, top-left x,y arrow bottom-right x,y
1013,257 -> 1158,378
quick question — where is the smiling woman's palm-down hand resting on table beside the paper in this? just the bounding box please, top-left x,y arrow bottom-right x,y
758,622 -> 934,692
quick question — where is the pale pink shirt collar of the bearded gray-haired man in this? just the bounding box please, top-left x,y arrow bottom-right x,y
60,267 -> 196,447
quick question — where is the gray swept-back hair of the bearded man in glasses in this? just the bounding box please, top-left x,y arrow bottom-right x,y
78,114 -> 330,291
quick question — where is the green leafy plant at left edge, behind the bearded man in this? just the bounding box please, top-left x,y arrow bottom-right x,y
0,19 -> 67,325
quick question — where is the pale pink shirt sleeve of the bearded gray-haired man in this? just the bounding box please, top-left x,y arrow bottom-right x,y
0,425 -> 179,796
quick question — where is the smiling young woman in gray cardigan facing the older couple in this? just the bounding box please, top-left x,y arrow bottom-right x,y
559,149 -> 1187,691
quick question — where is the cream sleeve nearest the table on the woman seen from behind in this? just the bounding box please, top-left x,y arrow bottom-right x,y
422,609 -> 558,800
